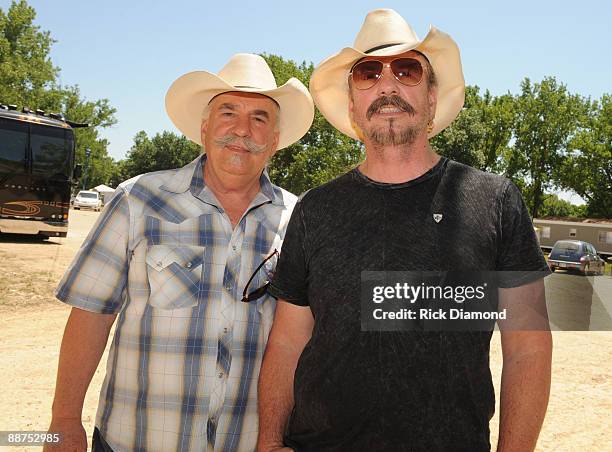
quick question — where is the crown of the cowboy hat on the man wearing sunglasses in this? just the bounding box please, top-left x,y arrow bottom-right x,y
353,9 -> 420,53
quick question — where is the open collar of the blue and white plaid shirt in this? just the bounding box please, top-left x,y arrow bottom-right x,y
160,154 -> 285,206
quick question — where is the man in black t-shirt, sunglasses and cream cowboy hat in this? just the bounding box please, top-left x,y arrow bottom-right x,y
258,9 -> 551,452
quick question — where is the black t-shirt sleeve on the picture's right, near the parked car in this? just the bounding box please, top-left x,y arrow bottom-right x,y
496,181 -> 550,288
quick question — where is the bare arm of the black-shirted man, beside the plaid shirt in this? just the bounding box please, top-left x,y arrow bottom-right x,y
257,299 -> 314,452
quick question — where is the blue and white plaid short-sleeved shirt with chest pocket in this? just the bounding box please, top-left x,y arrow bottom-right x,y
56,156 -> 297,451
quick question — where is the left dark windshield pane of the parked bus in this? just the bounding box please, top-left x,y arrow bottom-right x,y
0,118 -> 28,174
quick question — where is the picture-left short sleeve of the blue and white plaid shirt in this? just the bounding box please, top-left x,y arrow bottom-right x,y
55,188 -> 130,314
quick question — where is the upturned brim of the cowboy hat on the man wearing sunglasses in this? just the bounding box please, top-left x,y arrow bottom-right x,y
310,27 -> 465,140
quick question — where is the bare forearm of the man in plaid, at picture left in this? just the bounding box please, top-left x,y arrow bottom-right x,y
44,308 -> 117,451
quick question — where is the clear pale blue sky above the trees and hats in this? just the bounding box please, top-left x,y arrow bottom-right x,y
0,0 -> 612,201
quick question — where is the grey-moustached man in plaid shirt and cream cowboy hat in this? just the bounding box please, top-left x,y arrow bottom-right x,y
46,54 -> 314,451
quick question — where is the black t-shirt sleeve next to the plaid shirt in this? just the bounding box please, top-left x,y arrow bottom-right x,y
268,201 -> 308,306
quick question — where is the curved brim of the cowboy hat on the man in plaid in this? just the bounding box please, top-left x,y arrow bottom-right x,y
166,71 -> 314,149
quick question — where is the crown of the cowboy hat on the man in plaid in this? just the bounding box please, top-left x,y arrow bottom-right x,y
218,53 -> 277,90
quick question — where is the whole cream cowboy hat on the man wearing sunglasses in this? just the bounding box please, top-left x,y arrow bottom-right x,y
310,9 -> 465,140
